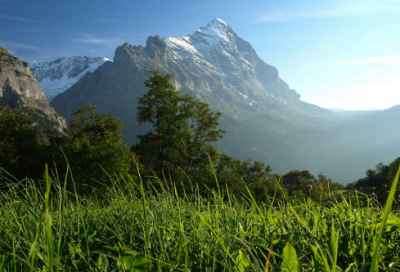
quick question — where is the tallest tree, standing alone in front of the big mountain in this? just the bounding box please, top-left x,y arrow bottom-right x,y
132,70 -> 225,182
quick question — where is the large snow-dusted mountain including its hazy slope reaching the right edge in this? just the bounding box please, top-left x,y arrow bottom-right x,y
27,19 -> 400,183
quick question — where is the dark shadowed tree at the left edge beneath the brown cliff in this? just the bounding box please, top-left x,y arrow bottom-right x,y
0,109 -> 44,182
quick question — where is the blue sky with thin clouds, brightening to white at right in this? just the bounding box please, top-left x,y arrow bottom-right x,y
0,0 -> 400,110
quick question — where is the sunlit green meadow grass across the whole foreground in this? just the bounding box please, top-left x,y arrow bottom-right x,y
0,165 -> 400,272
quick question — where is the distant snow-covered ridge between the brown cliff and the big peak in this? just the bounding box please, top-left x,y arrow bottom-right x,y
31,56 -> 110,102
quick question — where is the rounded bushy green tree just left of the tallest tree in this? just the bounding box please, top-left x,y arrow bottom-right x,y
48,105 -> 130,193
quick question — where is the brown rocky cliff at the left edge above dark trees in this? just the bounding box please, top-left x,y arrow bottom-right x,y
0,46 -> 66,134
